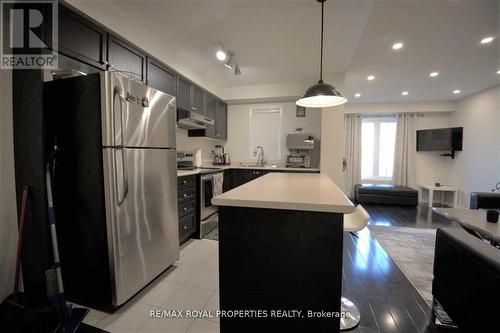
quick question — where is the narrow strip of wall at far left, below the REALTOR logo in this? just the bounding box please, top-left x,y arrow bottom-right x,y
0,70 -> 17,301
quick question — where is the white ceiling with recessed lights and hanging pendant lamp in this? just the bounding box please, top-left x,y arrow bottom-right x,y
93,0 -> 500,103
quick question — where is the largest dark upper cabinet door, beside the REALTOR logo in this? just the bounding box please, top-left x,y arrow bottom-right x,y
58,6 -> 107,69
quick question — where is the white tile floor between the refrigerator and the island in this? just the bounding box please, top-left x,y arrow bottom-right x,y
84,239 -> 219,333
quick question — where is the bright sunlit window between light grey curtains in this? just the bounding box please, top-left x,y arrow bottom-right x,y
361,117 -> 396,181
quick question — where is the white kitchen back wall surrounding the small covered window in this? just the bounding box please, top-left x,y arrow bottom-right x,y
226,102 -> 323,163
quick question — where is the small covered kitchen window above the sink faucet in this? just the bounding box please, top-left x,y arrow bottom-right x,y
249,106 -> 283,160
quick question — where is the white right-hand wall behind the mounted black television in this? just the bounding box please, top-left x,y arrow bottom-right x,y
449,86 -> 500,207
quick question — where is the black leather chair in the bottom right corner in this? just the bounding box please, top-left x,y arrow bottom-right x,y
432,228 -> 500,332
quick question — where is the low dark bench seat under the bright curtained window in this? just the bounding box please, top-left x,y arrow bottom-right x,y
354,184 -> 418,206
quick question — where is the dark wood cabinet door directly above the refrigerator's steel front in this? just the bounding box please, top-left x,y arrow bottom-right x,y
108,34 -> 146,83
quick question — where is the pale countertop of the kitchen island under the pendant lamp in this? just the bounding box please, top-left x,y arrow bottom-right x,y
212,172 -> 355,214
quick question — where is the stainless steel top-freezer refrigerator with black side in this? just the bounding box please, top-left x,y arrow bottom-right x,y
44,72 -> 179,309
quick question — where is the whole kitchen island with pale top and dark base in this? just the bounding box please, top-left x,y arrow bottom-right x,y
212,173 -> 354,333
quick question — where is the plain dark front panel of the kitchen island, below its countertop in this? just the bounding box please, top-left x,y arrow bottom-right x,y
219,206 -> 343,333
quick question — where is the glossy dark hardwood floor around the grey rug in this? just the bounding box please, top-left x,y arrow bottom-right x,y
342,205 -> 455,333
